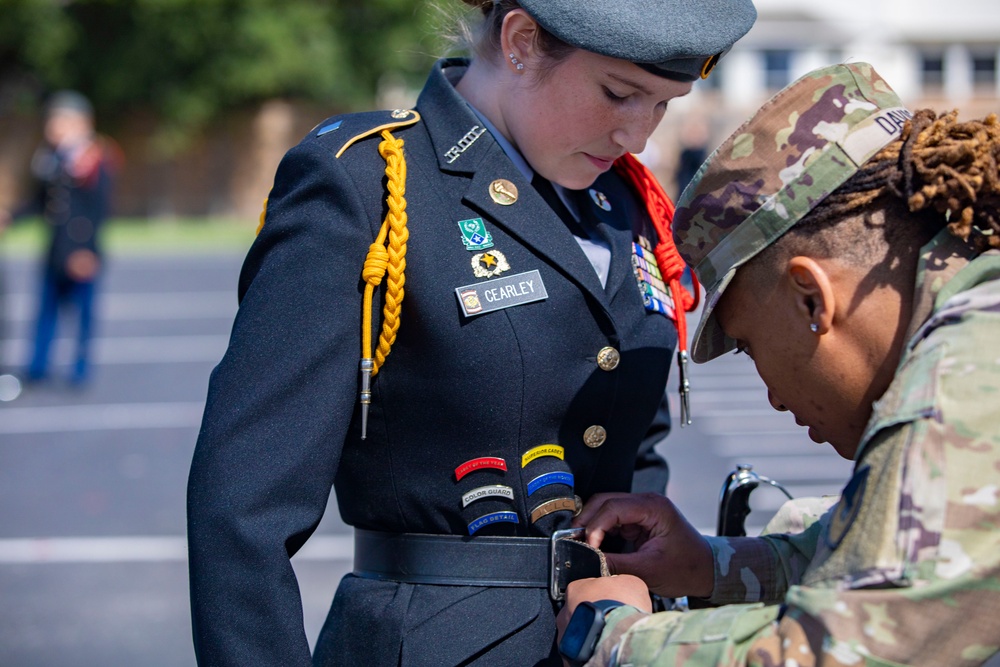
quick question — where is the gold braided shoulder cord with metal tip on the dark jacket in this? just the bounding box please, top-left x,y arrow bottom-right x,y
361,130 -> 410,440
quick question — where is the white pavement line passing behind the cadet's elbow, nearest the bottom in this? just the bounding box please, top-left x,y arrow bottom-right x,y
0,535 -> 354,564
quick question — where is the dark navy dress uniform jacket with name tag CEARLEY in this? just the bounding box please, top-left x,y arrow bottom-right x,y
188,61 -> 676,667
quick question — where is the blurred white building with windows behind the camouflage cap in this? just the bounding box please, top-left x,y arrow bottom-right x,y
657,0 -> 1000,196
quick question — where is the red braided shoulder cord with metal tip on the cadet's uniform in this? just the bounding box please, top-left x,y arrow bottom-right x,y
615,153 -> 700,427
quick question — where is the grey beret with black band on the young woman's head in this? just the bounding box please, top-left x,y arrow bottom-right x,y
520,0 -> 757,81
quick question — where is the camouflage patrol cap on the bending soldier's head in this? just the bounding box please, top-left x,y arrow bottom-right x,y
673,63 -> 912,363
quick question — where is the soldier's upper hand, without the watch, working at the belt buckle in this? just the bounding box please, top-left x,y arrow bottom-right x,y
573,493 -> 715,597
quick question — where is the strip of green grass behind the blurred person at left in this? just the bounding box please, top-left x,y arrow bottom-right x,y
0,218 -> 257,256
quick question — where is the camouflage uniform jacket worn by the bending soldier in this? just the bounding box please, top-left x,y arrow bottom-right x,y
589,230 -> 1000,667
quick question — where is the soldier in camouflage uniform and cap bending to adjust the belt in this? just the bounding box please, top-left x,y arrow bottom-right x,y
559,63 -> 1000,666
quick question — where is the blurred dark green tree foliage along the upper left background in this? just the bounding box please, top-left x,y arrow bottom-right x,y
0,0 -> 448,152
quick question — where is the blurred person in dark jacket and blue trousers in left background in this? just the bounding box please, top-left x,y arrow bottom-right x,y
0,90 -> 121,386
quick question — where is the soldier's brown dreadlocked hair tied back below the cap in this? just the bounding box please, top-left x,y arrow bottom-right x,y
800,109 -> 1000,248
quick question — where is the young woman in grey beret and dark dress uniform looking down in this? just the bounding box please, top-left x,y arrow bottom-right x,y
188,0 -> 755,667
